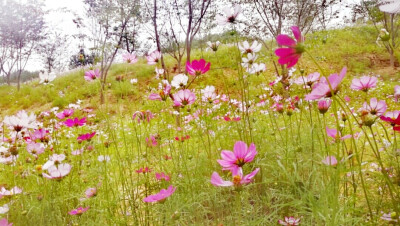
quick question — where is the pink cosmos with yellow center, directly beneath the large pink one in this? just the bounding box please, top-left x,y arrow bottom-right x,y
211,167 -> 260,187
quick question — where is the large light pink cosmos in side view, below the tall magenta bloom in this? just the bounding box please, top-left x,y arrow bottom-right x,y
305,67 -> 347,100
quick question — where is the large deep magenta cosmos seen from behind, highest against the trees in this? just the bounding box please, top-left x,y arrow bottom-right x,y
275,26 -> 305,68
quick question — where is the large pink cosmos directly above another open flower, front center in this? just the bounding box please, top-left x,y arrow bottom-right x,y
217,141 -> 257,170
